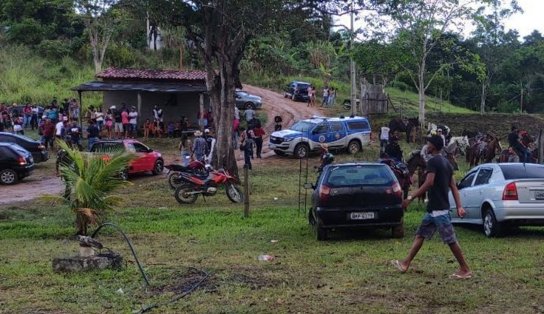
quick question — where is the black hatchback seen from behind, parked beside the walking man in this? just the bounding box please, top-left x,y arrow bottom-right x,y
308,163 -> 404,241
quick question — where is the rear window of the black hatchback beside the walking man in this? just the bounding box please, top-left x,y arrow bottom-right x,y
325,165 -> 394,187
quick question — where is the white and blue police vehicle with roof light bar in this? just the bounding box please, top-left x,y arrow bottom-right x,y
269,117 -> 370,158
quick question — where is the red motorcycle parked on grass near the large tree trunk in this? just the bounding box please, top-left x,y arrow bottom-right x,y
174,169 -> 244,204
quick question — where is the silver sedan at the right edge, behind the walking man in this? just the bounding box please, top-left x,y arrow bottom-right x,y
450,163 -> 544,237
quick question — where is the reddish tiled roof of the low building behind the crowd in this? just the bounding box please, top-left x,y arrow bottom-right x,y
96,68 -> 206,81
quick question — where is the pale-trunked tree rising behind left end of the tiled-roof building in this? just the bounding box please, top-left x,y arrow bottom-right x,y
75,0 -> 121,73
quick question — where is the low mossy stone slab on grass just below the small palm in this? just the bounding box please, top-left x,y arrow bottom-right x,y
53,252 -> 123,272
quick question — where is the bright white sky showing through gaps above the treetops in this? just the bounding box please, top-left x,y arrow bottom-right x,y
337,0 -> 544,40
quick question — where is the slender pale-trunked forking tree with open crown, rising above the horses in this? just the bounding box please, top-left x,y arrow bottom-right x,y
383,0 -> 516,124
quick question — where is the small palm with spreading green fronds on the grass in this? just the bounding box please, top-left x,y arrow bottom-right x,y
53,141 -> 134,235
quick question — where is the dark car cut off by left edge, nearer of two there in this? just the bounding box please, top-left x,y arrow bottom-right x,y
0,143 -> 34,184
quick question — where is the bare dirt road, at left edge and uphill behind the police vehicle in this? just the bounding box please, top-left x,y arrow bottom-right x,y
0,85 -> 323,206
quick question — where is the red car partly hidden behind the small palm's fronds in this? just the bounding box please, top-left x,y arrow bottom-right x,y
91,139 -> 164,179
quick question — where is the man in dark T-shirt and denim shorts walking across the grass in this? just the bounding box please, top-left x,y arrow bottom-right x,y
391,135 -> 472,279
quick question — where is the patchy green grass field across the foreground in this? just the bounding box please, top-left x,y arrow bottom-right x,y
0,136 -> 544,313
